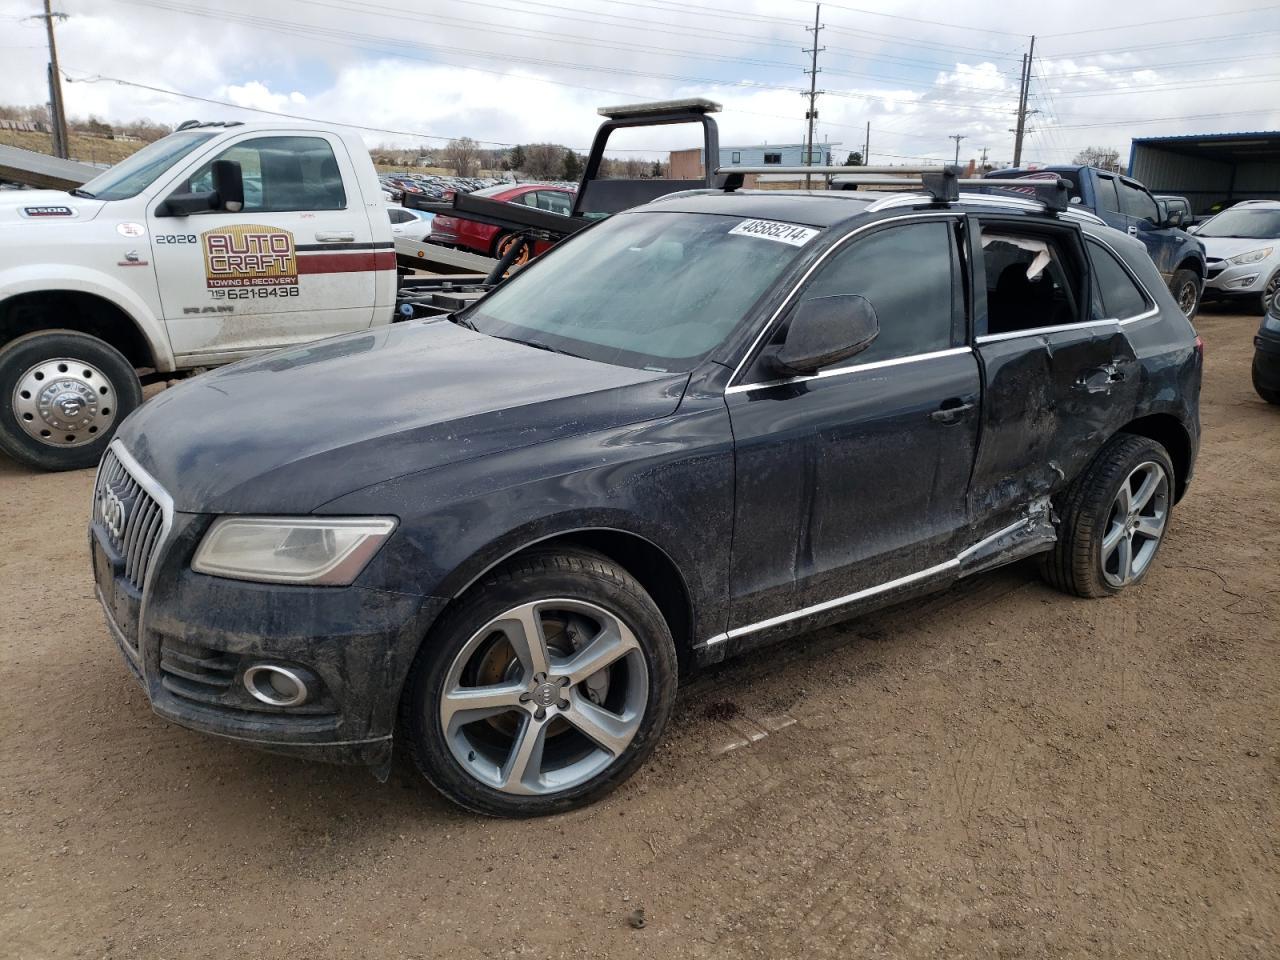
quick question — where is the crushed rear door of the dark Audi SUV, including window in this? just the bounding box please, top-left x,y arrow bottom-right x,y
969,218 -> 1140,530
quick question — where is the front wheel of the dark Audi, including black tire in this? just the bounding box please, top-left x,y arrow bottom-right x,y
401,549 -> 677,818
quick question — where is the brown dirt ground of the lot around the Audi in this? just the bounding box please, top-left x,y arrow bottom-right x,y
0,310 -> 1280,960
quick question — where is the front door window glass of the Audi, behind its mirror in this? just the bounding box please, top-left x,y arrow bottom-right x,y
800,220 -> 960,366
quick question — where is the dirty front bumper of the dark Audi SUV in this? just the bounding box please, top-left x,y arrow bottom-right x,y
90,504 -> 445,767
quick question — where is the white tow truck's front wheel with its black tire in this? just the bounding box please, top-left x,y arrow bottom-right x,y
0,330 -> 142,470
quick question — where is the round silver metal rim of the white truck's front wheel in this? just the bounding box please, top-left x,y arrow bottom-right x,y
13,357 -> 115,447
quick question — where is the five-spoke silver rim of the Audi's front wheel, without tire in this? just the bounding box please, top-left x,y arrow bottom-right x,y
439,599 -> 649,796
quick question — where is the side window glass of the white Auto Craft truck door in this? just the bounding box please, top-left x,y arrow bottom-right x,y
188,137 -> 347,214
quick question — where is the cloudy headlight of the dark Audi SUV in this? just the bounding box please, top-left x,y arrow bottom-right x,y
191,517 -> 396,586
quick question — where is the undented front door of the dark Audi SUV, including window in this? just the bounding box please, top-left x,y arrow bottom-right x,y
726,216 -> 979,634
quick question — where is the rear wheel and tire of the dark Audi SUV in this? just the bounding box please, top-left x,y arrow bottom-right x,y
1041,434 -> 1175,596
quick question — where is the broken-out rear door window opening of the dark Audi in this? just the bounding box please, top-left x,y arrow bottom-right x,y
980,224 -> 1083,334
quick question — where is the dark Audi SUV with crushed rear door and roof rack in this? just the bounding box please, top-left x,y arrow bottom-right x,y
90,191 -> 1202,815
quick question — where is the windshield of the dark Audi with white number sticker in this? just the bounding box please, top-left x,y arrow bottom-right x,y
465,211 -> 818,371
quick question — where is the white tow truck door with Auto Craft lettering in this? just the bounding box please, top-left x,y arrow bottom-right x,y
148,132 -> 384,360
